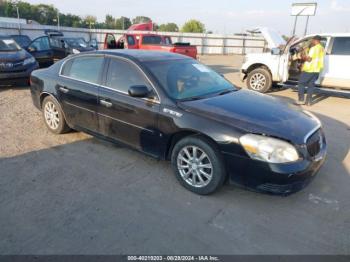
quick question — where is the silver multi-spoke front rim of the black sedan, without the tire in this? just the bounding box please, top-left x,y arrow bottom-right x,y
177,146 -> 213,188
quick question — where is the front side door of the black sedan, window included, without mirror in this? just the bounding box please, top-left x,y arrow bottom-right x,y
98,58 -> 159,156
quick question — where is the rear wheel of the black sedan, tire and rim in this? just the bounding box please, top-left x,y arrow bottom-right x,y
42,96 -> 71,134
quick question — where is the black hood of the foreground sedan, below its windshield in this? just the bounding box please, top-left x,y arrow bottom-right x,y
179,90 -> 318,144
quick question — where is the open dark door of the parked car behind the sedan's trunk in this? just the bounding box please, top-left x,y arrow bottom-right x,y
27,36 -> 54,67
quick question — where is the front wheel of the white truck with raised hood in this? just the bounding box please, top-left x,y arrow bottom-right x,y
247,68 -> 272,93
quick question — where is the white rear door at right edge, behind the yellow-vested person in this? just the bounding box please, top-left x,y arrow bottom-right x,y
321,37 -> 350,89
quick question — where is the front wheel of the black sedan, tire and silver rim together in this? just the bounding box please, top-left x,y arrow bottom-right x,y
171,136 -> 226,195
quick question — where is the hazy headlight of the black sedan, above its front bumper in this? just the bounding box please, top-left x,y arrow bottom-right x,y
239,134 -> 299,164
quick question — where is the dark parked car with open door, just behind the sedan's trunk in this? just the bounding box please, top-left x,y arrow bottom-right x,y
27,30 -> 94,67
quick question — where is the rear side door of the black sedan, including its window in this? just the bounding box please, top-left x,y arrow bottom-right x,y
56,55 -> 104,133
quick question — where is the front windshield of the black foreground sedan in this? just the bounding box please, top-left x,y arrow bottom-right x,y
145,59 -> 237,100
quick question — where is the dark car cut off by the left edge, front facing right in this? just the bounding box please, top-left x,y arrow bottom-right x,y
0,36 -> 39,85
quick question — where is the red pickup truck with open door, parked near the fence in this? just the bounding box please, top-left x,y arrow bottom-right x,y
104,32 -> 197,59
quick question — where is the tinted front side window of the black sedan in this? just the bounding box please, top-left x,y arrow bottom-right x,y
106,59 -> 152,93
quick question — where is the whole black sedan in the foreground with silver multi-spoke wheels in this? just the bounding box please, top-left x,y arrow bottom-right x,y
31,50 -> 326,194
